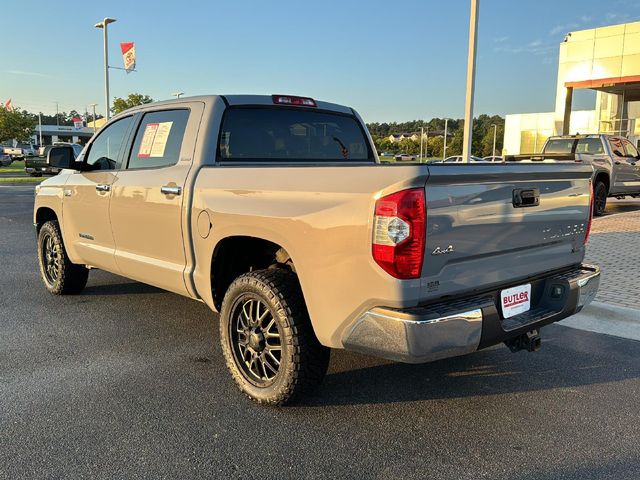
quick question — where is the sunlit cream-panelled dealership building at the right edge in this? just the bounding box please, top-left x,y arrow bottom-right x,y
503,22 -> 640,154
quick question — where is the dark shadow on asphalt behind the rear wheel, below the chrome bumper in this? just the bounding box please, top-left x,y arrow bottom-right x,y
307,325 -> 640,407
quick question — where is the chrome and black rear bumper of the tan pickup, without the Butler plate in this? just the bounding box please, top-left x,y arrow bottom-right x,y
343,265 -> 600,363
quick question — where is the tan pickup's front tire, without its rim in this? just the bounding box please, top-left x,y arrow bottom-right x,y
38,220 -> 89,295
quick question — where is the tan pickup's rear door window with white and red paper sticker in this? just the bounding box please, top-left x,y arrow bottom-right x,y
127,109 -> 189,169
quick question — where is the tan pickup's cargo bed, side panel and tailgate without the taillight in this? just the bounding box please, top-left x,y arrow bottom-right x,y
191,163 -> 591,347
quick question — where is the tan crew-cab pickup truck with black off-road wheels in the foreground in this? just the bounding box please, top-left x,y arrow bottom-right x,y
34,95 -> 599,404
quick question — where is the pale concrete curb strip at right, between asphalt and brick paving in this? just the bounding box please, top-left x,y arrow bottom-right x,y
558,302 -> 640,341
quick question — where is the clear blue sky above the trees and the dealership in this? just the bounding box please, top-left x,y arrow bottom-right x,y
0,0 -> 640,121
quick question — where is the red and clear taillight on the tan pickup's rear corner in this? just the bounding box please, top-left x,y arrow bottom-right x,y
372,188 -> 427,279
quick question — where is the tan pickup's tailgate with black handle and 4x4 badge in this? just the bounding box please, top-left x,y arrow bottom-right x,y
421,163 -> 592,299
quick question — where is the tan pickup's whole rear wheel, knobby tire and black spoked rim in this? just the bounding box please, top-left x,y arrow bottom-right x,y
220,268 -> 330,405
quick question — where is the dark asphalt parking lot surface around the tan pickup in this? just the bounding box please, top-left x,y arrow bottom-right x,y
0,186 -> 640,480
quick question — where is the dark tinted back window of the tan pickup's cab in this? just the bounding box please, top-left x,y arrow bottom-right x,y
218,107 -> 373,163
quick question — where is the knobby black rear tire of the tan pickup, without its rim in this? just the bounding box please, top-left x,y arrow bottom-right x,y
220,268 -> 330,405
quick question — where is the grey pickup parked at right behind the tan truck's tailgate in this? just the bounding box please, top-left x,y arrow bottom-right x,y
506,134 -> 640,216
